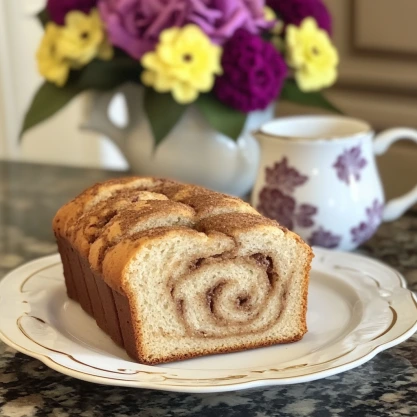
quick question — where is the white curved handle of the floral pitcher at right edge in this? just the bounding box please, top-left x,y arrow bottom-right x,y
374,127 -> 417,221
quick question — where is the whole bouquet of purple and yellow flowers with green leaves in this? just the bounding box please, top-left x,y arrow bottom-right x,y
21,0 -> 338,145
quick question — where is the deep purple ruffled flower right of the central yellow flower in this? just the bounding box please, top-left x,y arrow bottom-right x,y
214,29 -> 287,113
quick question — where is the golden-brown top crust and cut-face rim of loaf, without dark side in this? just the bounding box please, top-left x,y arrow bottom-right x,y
53,177 -> 313,364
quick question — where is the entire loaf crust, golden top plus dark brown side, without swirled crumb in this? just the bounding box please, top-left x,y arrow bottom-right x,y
53,177 -> 313,365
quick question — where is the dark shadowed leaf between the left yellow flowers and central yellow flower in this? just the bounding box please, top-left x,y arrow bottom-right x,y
77,57 -> 141,90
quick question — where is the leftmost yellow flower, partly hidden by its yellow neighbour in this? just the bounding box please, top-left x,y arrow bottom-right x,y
36,22 -> 70,87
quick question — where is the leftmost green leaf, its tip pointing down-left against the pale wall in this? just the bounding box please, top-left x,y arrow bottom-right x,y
19,81 -> 82,139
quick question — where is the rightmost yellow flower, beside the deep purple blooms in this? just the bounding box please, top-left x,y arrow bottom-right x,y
286,17 -> 339,92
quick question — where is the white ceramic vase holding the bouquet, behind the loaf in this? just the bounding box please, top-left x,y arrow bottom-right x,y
81,84 -> 274,196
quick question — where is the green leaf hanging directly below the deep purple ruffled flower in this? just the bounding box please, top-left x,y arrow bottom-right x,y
196,94 -> 246,140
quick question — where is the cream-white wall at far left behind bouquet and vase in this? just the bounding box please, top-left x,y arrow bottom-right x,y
0,0 -> 101,166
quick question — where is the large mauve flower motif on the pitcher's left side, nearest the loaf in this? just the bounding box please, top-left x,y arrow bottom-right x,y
257,157 -> 318,229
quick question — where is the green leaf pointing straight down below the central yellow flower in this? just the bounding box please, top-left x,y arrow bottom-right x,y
143,88 -> 187,148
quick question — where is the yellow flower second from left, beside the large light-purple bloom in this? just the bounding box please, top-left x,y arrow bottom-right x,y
58,9 -> 113,68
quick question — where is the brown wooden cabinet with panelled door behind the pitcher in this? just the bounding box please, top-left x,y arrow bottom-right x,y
278,0 -> 417,205
